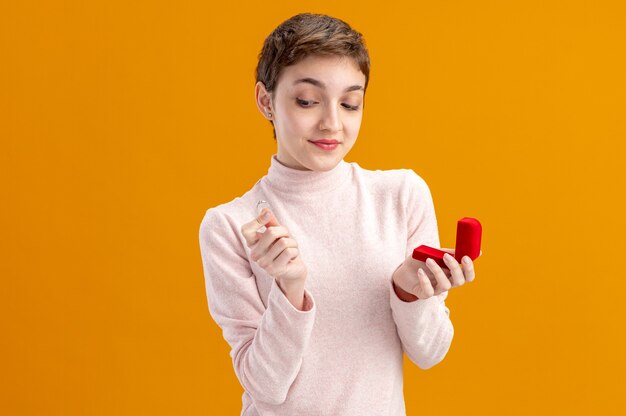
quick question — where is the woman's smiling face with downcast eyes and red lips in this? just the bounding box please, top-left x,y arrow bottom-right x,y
257,56 -> 365,171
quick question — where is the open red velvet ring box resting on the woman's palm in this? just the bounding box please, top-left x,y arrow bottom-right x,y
412,217 -> 483,269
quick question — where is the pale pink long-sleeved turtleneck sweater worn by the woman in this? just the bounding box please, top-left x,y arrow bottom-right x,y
199,155 -> 454,416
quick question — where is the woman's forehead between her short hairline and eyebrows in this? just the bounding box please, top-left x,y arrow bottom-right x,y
277,55 -> 365,90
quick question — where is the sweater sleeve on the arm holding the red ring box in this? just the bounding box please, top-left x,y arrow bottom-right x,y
389,170 -> 454,369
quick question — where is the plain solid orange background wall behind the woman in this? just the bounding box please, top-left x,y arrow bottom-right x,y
0,0 -> 626,415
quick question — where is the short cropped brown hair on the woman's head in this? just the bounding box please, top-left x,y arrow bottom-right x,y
256,13 -> 370,139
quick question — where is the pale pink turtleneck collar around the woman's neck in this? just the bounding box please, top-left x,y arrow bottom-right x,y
266,154 -> 351,195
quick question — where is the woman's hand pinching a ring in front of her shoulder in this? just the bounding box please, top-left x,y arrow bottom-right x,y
241,208 -> 307,286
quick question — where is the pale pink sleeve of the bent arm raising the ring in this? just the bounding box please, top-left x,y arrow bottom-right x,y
199,208 -> 316,405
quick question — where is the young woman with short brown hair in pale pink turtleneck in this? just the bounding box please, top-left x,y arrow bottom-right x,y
199,13 -> 474,416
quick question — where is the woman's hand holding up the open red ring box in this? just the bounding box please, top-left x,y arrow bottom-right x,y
393,248 -> 482,300
